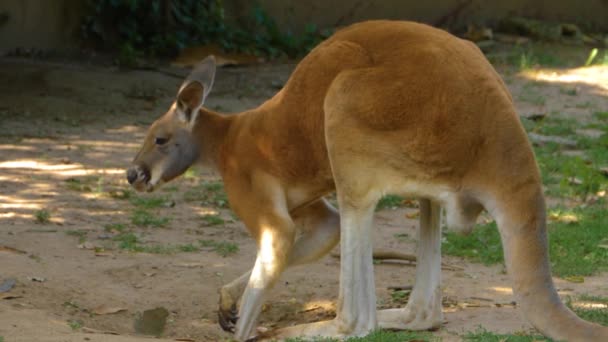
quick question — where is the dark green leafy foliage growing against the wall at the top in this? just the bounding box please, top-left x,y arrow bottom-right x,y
81,0 -> 331,61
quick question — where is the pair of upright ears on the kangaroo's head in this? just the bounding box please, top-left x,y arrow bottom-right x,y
177,56 -> 215,124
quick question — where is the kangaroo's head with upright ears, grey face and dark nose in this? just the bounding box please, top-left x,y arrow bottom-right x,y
127,56 -> 215,191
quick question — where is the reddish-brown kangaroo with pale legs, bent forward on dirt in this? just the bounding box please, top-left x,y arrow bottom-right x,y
127,21 -> 608,341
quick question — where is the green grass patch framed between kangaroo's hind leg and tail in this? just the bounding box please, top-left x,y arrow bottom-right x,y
441,222 -> 504,265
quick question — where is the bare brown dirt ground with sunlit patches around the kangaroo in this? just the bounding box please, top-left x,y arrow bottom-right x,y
0,46 -> 608,342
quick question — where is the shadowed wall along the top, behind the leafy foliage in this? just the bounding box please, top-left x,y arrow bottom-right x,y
0,0 -> 608,54
